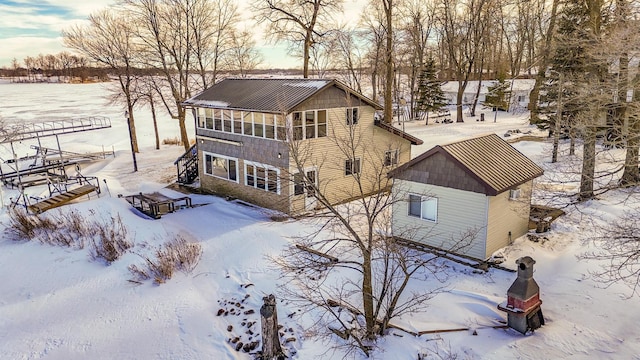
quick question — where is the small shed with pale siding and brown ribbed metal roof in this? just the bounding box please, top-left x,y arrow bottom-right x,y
389,134 -> 543,260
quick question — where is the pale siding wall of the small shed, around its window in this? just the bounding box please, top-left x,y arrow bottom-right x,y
391,179 -> 488,259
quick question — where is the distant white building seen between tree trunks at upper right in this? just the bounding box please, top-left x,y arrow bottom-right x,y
442,79 -> 535,111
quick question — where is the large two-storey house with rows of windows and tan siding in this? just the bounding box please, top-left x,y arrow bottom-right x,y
183,78 -> 422,214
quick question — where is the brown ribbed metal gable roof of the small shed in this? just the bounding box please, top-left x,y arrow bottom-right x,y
389,134 -> 544,195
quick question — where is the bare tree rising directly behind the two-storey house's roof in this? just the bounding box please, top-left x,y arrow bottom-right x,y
253,0 -> 343,78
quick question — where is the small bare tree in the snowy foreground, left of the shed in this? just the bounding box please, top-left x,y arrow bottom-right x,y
274,102 -> 470,356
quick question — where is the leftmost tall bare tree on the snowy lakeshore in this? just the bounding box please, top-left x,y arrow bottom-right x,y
62,9 -> 139,152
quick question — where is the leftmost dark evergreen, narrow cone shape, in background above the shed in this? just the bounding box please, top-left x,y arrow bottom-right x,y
415,58 -> 447,125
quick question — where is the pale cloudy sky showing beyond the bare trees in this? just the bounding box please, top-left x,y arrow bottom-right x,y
0,0 -> 366,68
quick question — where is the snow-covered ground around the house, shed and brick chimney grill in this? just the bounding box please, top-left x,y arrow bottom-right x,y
0,83 -> 640,360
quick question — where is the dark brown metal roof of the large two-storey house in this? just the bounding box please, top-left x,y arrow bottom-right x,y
183,78 -> 380,113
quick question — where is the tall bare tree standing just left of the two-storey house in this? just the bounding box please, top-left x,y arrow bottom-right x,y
122,0 -> 233,150
